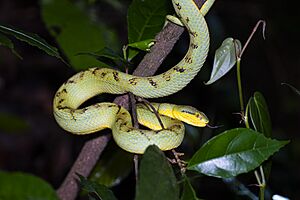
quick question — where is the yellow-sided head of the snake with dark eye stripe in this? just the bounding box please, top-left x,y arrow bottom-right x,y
173,105 -> 209,127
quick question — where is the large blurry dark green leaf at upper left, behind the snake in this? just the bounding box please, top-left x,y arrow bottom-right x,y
41,0 -> 118,70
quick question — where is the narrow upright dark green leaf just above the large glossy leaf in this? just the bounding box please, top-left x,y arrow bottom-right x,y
247,92 -> 272,137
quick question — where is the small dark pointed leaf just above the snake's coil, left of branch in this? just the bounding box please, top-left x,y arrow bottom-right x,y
77,47 -> 128,68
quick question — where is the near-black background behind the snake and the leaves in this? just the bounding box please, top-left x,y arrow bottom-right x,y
0,0 -> 300,199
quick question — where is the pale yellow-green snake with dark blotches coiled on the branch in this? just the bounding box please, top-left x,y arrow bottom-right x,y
53,0 -> 214,154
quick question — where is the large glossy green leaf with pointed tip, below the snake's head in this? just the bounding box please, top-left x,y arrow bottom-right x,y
187,128 -> 289,178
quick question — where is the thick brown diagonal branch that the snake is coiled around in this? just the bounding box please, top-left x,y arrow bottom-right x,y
56,0 -> 203,200
